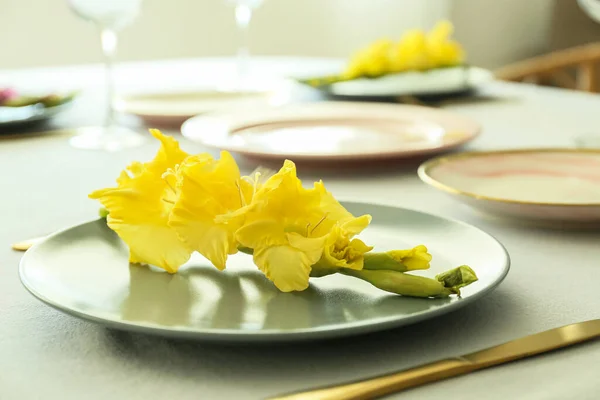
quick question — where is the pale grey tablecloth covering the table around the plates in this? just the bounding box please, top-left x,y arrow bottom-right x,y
0,57 -> 600,400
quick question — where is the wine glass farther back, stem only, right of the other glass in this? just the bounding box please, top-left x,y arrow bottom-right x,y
225,0 -> 264,89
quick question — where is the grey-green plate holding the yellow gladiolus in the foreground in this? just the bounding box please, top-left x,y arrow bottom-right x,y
20,202 -> 510,342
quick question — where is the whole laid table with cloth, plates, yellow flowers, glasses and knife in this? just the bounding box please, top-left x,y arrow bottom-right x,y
0,0 -> 600,400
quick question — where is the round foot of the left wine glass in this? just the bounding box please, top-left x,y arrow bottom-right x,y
69,126 -> 146,151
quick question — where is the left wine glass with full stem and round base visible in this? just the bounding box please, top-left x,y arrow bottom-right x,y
68,0 -> 144,151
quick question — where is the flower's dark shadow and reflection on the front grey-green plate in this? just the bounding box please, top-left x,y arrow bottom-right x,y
121,265 -> 453,334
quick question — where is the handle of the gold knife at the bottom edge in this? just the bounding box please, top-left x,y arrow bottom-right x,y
271,358 -> 477,400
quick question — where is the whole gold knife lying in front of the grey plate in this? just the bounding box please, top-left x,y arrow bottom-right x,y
271,319 -> 600,400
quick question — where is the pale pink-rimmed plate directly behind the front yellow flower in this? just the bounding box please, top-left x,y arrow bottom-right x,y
182,102 -> 480,161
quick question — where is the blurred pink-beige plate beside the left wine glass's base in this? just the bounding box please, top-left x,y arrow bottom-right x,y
116,90 -> 273,126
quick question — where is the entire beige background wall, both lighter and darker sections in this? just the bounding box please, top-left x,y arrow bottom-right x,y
0,0 -> 592,69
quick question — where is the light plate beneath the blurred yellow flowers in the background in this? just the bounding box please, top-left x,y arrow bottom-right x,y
310,67 -> 494,97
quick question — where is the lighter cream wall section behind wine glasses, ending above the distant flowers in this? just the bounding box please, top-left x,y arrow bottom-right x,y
0,0 -> 448,68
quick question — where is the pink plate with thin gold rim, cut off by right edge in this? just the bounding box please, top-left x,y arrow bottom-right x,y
419,149 -> 600,226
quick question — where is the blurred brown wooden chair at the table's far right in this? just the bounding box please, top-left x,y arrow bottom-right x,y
495,42 -> 600,92
